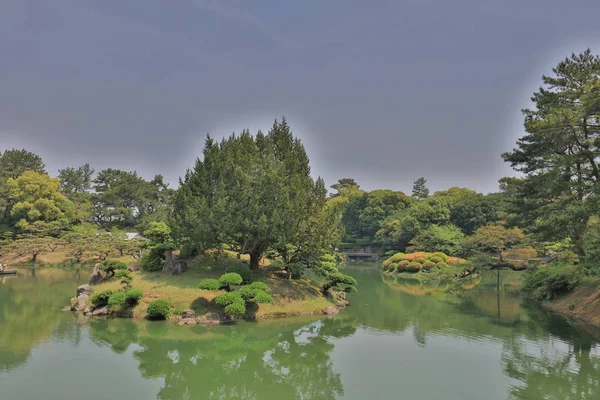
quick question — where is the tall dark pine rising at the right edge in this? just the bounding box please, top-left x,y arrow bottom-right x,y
503,50 -> 600,255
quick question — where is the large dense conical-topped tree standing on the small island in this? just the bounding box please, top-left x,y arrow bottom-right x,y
173,119 -> 336,270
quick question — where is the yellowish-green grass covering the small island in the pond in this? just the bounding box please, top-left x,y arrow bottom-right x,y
93,253 -> 332,319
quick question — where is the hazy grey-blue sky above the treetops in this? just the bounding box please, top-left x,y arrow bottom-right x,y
0,0 -> 600,192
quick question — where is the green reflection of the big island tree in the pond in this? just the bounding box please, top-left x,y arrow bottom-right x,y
90,319 -> 355,399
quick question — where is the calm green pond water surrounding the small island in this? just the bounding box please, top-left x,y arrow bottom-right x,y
0,265 -> 600,400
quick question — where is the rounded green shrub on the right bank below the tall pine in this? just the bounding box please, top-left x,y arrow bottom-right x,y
521,265 -> 581,301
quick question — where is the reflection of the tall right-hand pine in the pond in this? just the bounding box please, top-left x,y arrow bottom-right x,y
502,314 -> 600,400
